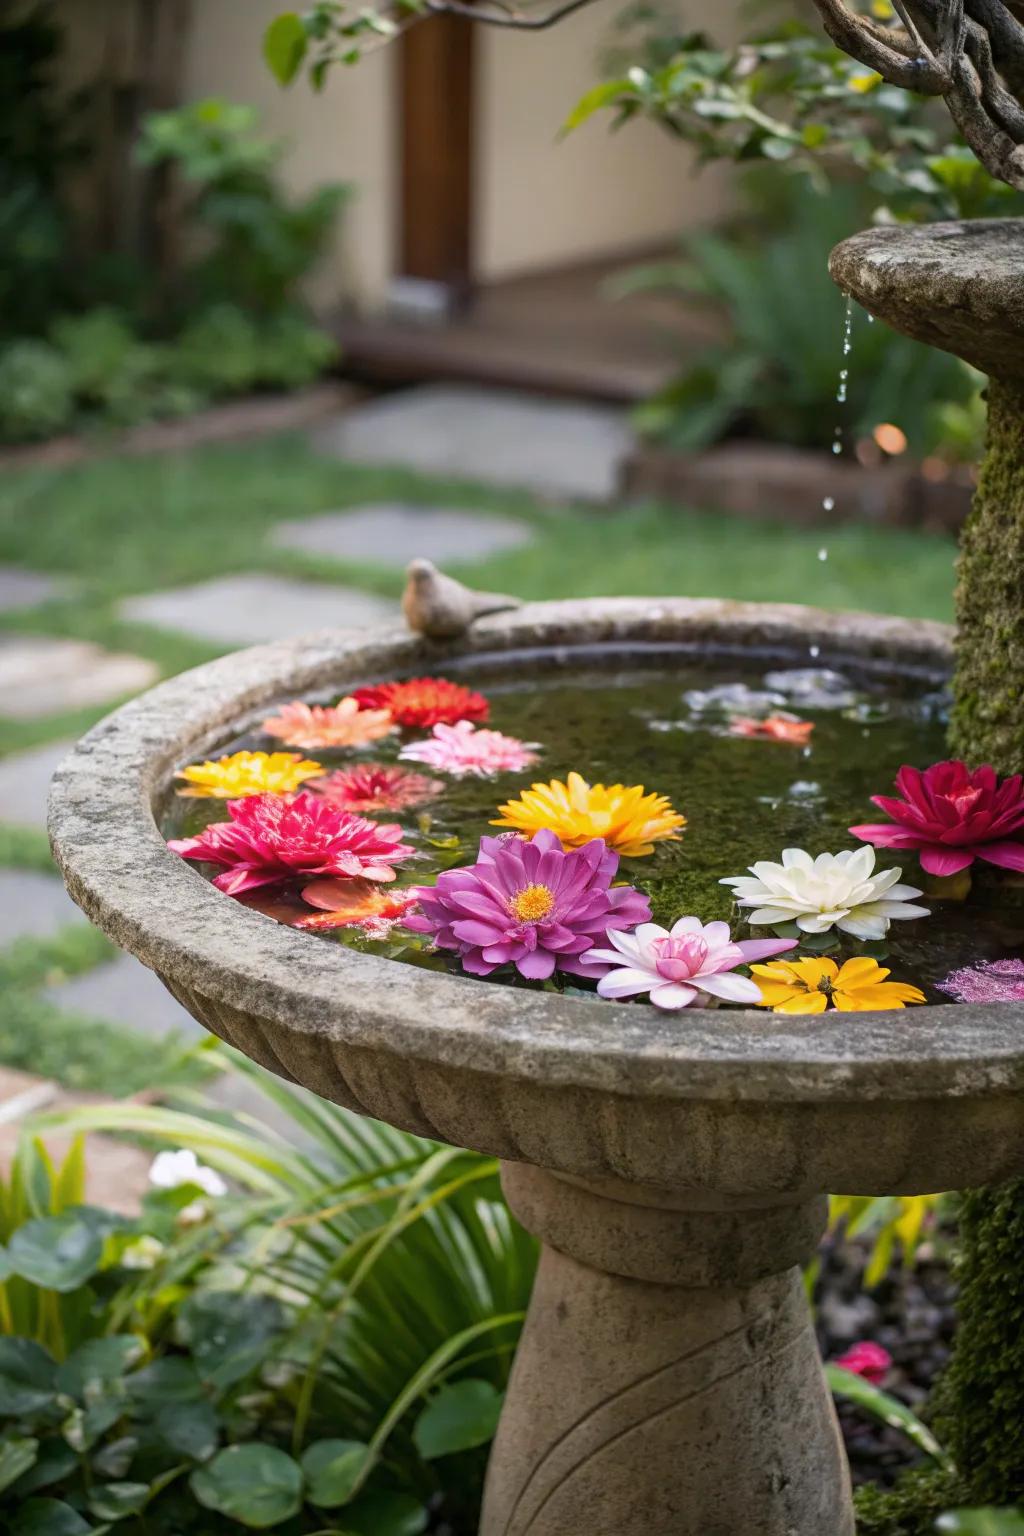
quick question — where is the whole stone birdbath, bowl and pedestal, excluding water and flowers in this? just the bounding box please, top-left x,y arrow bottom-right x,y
51,599 -> 1024,1536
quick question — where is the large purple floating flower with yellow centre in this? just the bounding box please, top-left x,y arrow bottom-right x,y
405,831 -> 651,982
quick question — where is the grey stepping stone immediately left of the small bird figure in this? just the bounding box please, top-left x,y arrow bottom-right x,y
120,576 -> 399,647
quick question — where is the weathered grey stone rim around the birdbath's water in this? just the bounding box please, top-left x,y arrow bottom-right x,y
49,599 -> 1024,1104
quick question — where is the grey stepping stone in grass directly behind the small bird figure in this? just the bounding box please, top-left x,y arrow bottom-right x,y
270,501 -> 533,567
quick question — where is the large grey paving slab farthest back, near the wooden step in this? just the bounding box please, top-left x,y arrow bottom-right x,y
313,384 -> 633,501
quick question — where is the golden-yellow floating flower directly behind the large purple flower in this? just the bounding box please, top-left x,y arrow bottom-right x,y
491,773 -> 686,859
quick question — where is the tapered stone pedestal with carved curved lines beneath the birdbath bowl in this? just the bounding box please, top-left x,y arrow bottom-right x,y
481,1163 -> 854,1536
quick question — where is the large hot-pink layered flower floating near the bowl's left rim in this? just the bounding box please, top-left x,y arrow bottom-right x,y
167,793 -> 415,895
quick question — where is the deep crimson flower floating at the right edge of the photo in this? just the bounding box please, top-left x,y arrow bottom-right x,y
851,760 -> 1024,876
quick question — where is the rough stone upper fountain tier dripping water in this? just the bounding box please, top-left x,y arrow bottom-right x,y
829,218 -> 1024,382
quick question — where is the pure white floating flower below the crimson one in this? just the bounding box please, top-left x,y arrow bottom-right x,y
718,848 -> 929,938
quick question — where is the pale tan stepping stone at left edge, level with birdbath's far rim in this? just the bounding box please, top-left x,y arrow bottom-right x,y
0,634 -> 160,720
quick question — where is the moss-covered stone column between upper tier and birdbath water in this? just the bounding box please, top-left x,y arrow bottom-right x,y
950,379 -> 1024,773
